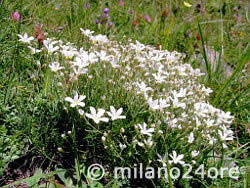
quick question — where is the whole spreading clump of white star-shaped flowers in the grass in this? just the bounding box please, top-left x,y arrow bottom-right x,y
19,29 -> 233,165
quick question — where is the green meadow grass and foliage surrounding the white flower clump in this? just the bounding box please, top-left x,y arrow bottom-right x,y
0,0 -> 250,187
